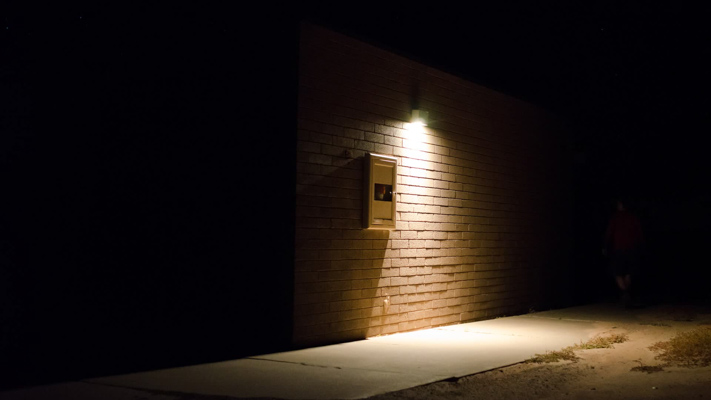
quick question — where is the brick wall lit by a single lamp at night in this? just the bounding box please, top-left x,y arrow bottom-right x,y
294,24 -> 571,345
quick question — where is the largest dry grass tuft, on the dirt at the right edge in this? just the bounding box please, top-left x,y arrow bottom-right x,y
649,326 -> 711,367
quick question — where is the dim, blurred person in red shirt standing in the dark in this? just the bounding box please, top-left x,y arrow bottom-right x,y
602,199 -> 644,306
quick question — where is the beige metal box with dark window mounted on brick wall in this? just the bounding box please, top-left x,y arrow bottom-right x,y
363,153 -> 397,229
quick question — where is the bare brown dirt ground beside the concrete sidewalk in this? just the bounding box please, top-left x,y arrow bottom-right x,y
369,305 -> 711,400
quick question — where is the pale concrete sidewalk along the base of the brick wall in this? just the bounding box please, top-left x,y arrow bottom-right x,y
0,305 -> 634,400
